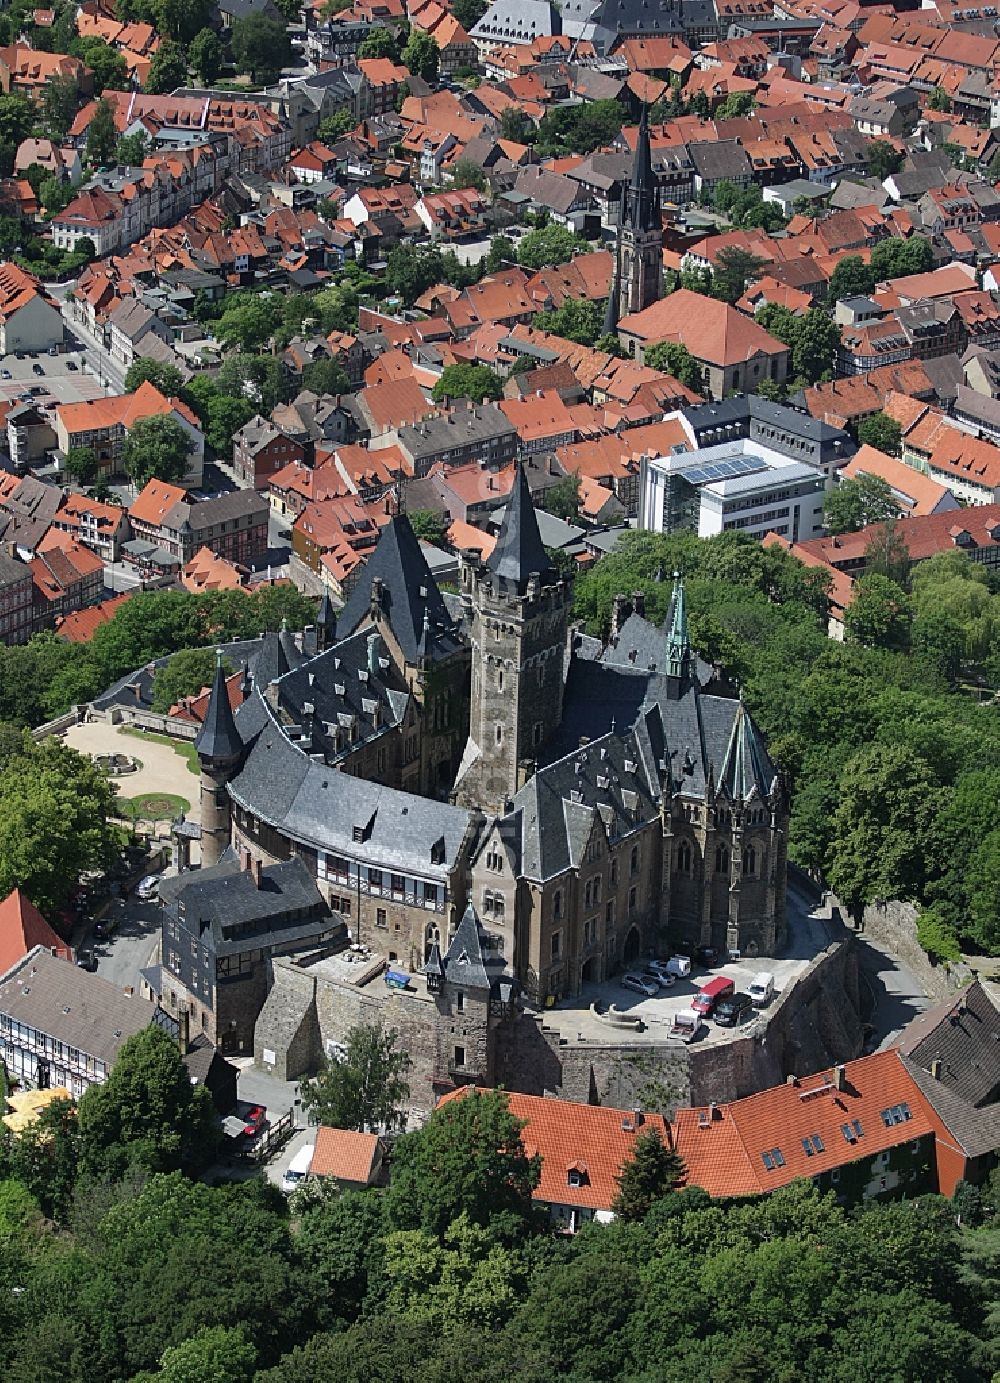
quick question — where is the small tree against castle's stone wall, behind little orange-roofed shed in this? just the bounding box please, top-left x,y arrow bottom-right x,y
302,1022 -> 411,1133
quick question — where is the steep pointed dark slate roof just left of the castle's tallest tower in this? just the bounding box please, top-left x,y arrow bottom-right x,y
339,514 -> 459,664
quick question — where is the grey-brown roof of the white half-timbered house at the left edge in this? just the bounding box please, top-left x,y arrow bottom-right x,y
0,946 -> 156,1068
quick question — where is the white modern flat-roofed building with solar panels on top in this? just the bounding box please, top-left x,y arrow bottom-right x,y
639,438 -> 826,542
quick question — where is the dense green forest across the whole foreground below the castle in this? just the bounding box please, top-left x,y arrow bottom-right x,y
0,1028 -> 1000,1383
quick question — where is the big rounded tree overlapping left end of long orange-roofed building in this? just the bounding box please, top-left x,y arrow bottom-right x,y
387,1090 -> 541,1238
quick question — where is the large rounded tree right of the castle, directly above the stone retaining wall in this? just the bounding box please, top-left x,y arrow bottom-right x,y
827,744 -> 939,911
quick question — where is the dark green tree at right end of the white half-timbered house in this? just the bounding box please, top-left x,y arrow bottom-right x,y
79,1025 -> 220,1177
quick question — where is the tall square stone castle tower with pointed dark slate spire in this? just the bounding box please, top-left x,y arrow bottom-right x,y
454,466 -> 573,815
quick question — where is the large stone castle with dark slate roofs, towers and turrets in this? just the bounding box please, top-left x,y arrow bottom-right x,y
196,469 -> 787,1007
